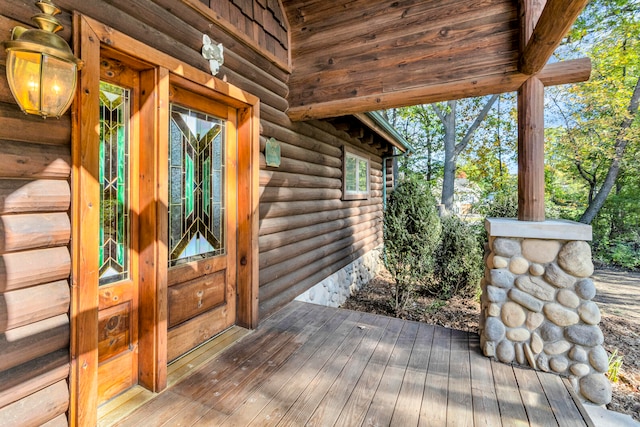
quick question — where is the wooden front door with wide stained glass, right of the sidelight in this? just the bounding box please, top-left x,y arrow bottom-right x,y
167,80 -> 237,361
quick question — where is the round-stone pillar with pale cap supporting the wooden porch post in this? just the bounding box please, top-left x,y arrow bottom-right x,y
480,218 -> 611,405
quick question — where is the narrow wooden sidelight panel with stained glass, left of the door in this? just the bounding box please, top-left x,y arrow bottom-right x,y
94,65 -> 145,403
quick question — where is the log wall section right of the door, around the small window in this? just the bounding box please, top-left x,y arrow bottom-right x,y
260,113 -> 387,316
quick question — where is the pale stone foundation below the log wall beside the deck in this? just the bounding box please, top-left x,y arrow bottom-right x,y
296,248 -> 382,307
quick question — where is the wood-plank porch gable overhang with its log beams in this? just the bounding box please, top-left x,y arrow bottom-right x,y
282,0 -> 591,120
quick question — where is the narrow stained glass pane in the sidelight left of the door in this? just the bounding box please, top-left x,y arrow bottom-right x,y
98,82 -> 130,285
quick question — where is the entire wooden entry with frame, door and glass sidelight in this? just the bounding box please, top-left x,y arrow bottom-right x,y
69,16 -> 259,425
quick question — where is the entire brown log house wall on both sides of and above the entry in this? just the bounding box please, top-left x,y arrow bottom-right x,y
0,0 -> 387,425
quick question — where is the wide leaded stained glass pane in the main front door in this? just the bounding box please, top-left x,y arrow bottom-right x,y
169,104 -> 225,266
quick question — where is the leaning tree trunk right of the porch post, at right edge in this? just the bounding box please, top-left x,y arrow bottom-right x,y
580,78 -> 640,224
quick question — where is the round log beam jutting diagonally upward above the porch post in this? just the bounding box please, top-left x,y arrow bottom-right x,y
519,0 -> 589,75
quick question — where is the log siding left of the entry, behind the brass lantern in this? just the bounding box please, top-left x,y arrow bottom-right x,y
0,5 -> 71,425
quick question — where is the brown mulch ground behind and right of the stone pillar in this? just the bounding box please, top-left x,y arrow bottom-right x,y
342,271 -> 640,421
